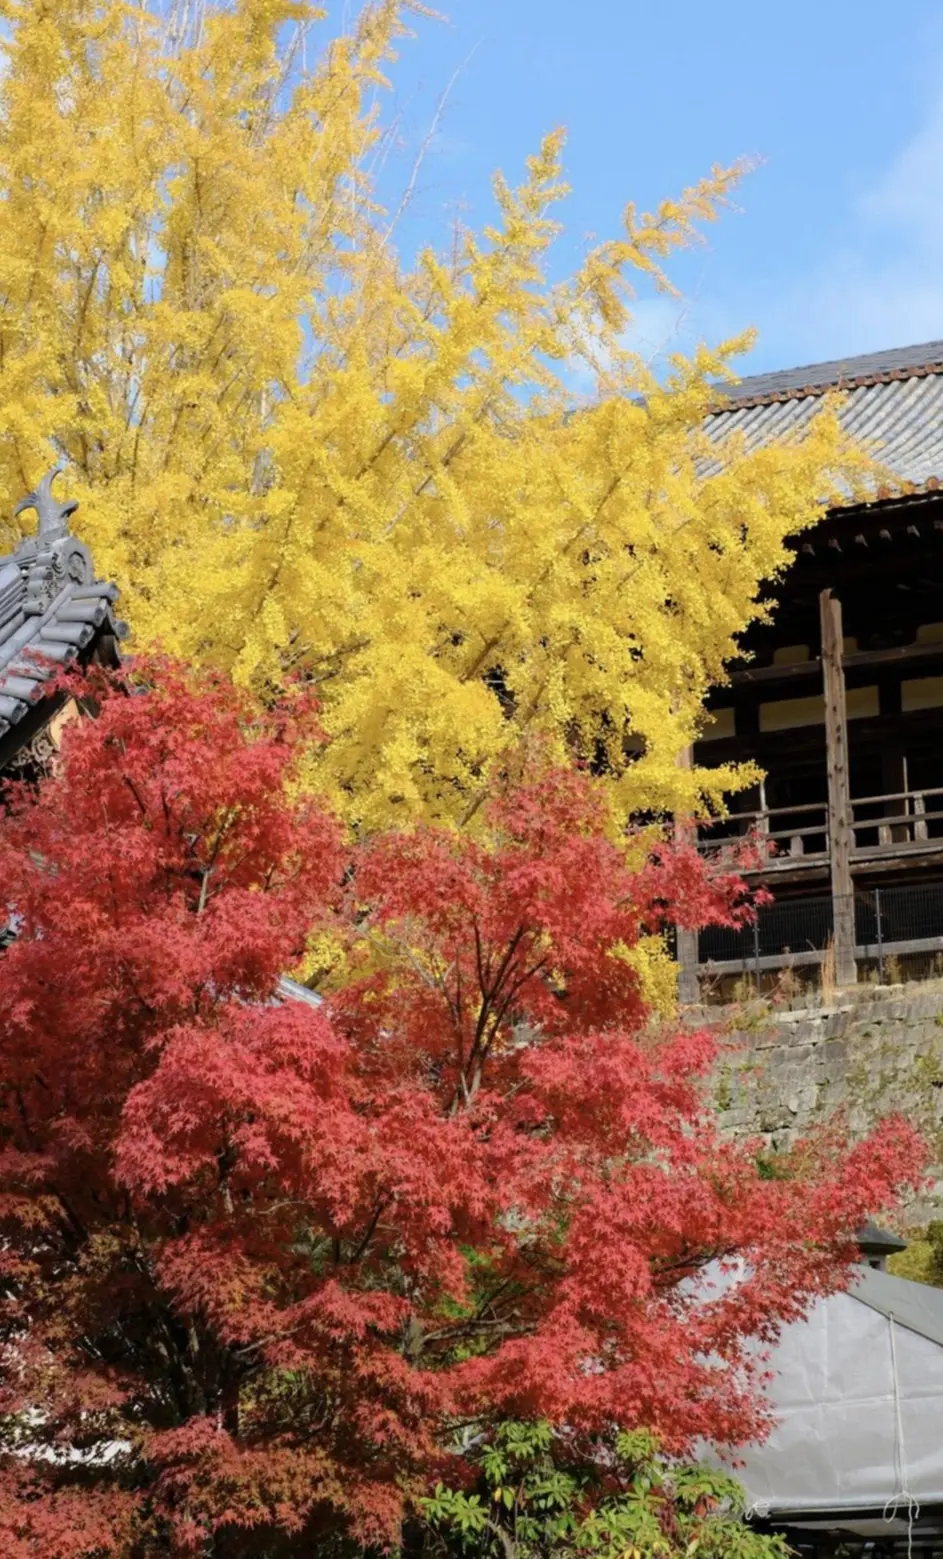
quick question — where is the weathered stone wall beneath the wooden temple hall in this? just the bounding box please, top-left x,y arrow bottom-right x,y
700,981 -> 943,1216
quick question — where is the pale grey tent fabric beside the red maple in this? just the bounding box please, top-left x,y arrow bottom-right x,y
720,1267 -> 943,1518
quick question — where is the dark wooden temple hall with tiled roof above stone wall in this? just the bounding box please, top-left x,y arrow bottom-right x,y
695,341 -> 943,999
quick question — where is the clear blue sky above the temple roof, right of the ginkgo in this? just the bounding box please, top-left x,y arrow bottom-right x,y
330,0 -> 943,371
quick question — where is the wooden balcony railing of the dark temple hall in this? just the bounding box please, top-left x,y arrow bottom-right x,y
698,787 -> 943,870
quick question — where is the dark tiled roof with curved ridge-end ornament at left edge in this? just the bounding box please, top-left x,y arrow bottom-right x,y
0,468 -> 128,737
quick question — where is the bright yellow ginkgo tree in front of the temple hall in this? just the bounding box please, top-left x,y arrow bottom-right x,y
0,0 -> 857,828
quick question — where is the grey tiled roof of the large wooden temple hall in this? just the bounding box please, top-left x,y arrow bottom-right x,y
708,341 -> 943,496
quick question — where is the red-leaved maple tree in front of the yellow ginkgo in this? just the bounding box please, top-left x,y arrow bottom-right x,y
0,663 -> 920,1559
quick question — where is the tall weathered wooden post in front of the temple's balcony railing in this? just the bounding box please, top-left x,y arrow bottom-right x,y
818,589 -> 857,985
